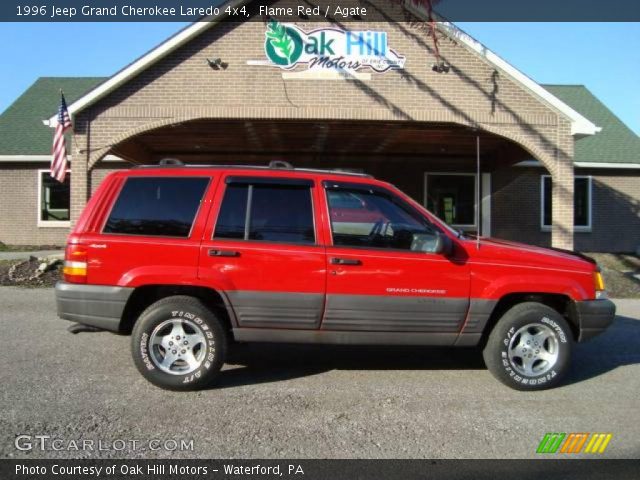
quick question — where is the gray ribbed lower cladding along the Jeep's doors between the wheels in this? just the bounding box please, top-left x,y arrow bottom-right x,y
229,292 -> 496,346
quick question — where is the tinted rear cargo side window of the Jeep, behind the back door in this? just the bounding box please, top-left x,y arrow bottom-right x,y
103,177 -> 209,238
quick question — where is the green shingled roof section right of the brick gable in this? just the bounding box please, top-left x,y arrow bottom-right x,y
542,85 -> 640,163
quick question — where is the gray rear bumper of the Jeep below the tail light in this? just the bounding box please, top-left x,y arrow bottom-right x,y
55,282 -> 133,332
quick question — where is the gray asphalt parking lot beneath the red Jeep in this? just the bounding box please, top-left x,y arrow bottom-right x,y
0,287 -> 640,458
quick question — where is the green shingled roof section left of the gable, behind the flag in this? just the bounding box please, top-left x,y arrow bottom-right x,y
0,77 -> 105,155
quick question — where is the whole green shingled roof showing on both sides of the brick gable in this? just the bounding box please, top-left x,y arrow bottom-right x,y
0,77 -> 640,163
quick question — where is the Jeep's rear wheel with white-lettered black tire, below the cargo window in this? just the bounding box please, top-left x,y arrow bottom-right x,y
131,295 -> 227,390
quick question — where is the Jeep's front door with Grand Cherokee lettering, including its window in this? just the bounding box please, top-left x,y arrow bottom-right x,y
322,183 -> 469,338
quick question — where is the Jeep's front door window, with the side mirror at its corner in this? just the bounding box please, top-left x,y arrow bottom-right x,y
327,188 -> 437,251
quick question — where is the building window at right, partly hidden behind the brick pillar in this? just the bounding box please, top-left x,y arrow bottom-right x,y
540,175 -> 592,232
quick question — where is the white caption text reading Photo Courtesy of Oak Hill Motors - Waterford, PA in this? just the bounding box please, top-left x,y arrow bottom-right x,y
15,464 -> 304,477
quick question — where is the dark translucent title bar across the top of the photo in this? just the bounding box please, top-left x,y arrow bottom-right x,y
0,0 -> 640,23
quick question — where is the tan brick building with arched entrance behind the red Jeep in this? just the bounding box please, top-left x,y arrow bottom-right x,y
0,10 -> 640,251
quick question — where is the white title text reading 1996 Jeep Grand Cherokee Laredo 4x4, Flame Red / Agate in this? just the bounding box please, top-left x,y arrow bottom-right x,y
25,5 -> 367,18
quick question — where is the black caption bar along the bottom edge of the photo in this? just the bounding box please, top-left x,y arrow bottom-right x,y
0,459 -> 640,480
